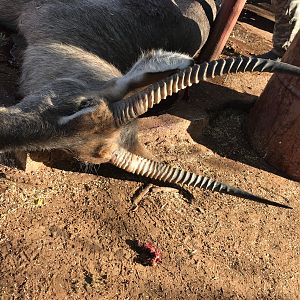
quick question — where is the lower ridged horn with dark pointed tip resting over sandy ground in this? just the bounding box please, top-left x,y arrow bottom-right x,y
110,148 -> 291,208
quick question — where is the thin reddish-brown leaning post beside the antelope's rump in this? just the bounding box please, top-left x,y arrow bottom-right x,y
199,0 -> 246,61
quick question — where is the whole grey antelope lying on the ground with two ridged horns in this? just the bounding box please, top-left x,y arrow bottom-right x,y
0,0 -> 300,207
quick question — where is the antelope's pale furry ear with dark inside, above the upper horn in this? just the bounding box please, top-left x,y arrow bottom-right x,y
115,50 -> 194,98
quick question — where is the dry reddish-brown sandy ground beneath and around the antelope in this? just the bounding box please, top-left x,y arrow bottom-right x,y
0,9 -> 300,300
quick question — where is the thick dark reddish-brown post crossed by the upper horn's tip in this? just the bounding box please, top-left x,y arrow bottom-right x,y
248,32 -> 300,181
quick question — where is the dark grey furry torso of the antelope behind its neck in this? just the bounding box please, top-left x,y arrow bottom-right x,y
0,0 -> 216,72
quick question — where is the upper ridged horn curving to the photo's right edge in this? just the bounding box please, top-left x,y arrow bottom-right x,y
112,56 -> 300,126
